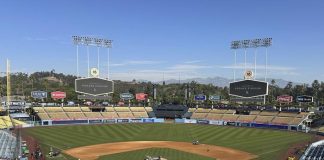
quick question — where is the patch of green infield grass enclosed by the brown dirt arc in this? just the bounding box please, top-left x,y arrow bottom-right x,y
99,148 -> 215,160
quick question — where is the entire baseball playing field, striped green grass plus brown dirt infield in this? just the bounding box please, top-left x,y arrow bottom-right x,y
23,124 -> 311,160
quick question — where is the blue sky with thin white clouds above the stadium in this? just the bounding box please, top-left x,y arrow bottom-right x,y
0,0 -> 324,83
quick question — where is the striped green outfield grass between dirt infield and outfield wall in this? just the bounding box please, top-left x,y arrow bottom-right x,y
24,124 -> 311,160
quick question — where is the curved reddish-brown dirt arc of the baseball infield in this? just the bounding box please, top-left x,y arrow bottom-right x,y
64,141 -> 257,160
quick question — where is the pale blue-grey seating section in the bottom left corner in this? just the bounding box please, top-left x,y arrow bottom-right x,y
0,130 -> 16,159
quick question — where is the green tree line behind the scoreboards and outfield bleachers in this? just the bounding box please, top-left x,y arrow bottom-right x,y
0,70 -> 324,105
